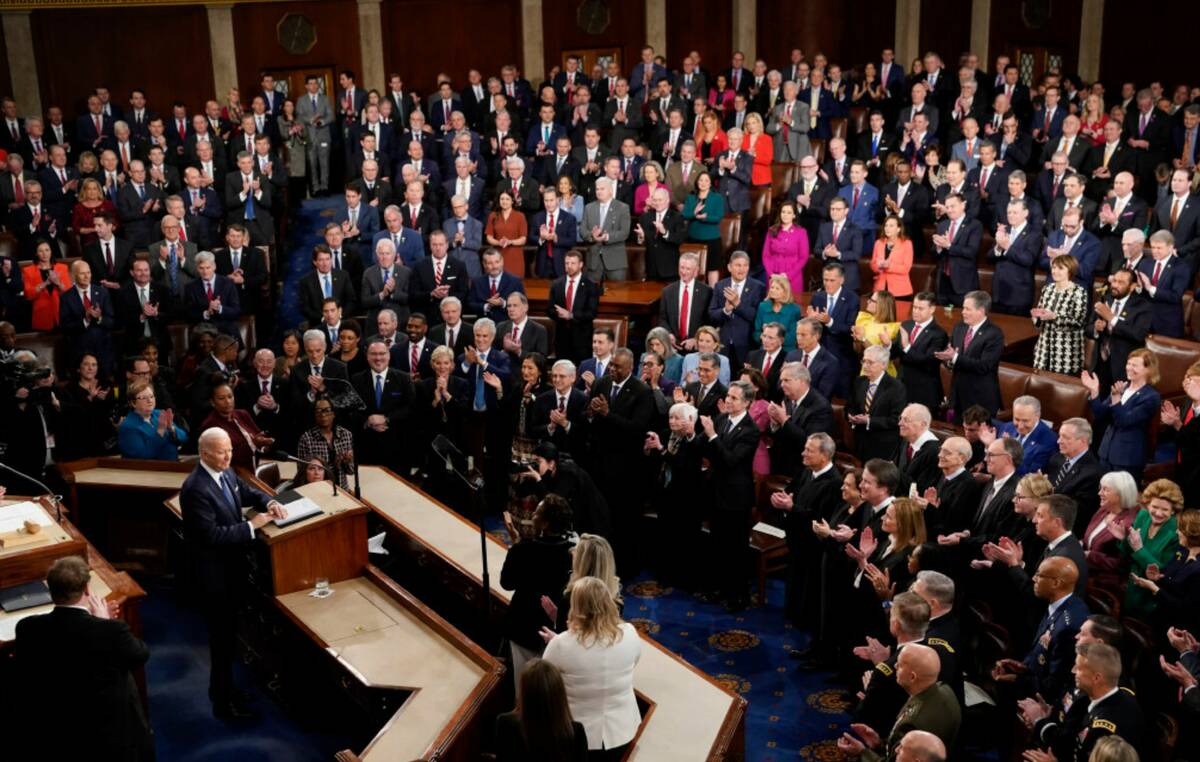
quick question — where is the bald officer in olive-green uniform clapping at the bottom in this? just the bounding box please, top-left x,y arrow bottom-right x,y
838,643 -> 962,762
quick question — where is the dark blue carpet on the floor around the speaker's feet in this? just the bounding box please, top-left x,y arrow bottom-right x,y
142,584 -> 353,762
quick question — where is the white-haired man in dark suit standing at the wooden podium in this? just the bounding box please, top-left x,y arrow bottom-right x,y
179,429 -> 286,720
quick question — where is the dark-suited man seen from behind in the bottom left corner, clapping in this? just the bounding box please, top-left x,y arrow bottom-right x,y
10,556 -> 154,760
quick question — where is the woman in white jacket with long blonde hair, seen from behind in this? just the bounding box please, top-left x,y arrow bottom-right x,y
542,577 -> 642,760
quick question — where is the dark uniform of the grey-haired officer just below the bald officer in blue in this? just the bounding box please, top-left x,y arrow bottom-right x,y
1034,688 -> 1144,762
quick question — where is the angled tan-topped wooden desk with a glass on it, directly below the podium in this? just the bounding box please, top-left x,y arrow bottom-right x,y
276,566 -> 504,761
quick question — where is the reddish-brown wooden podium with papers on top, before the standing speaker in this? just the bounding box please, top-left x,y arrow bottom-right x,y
246,481 -> 370,595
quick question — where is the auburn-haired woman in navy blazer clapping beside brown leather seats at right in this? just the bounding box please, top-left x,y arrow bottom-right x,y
1081,349 -> 1163,482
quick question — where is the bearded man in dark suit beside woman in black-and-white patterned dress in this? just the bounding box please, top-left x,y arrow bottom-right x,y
1086,266 -> 1153,394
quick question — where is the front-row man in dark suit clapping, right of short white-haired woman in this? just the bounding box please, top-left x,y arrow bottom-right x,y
697,380 -> 761,611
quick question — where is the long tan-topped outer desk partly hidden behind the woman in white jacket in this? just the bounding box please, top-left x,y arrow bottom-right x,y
359,466 -> 746,762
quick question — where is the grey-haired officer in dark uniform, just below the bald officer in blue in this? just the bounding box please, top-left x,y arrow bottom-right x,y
1026,643 -> 1144,762
